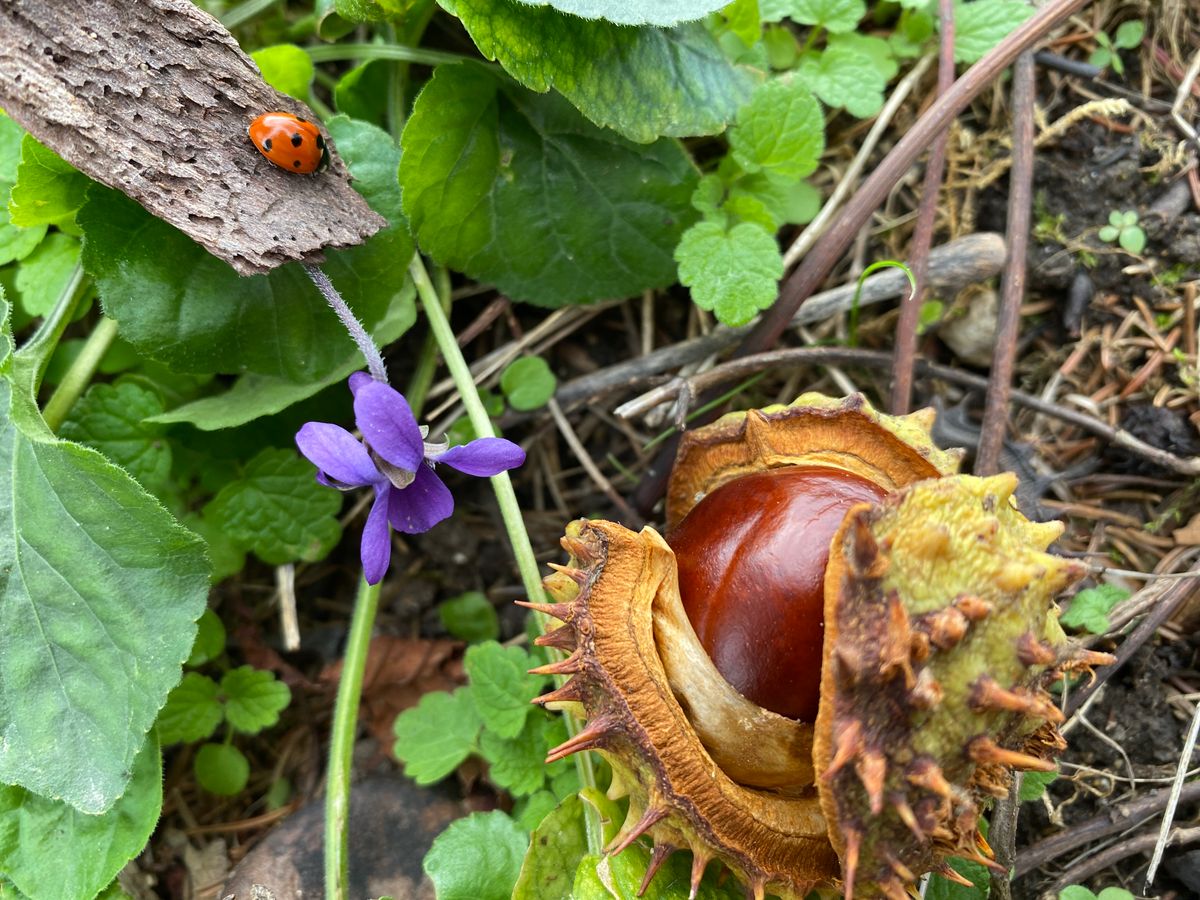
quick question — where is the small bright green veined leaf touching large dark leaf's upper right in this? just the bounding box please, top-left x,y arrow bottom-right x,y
730,78 -> 824,178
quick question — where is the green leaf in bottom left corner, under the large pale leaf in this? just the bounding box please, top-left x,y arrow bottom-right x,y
0,736 -> 162,900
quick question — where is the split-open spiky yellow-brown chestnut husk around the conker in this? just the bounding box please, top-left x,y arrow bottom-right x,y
539,395 -> 1099,900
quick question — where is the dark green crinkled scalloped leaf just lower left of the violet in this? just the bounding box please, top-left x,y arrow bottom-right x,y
204,448 -> 342,565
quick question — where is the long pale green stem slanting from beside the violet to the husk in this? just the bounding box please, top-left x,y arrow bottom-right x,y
408,256 -> 604,853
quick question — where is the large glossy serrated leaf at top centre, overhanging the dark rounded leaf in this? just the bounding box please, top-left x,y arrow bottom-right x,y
442,0 -> 756,143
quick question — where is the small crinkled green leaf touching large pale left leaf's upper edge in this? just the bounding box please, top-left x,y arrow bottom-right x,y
59,382 -> 172,492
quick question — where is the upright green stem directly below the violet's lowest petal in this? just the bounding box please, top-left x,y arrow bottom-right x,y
325,580 -> 379,900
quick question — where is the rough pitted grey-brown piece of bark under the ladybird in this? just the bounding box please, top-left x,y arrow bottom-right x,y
0,0 -> 386,275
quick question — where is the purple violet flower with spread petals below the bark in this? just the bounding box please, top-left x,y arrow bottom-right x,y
296,372 -> 524,584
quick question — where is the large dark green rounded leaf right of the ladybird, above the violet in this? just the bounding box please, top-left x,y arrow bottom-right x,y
400,64 -> 696,306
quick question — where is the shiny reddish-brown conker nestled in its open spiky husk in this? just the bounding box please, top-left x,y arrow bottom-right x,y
667,466 -> 887,721
